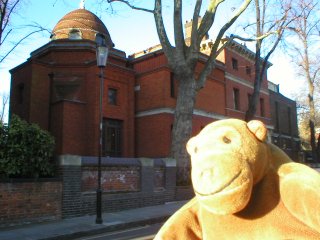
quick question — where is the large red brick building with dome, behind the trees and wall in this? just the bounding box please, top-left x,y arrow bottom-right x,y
10,9 -> 296,157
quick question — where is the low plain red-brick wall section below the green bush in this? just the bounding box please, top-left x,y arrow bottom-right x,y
0,179 -> 62,228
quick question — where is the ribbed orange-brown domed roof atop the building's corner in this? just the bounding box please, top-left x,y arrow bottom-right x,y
51,9 -> 111,44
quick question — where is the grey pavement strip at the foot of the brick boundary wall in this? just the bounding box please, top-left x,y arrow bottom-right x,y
0,201 -> 187,240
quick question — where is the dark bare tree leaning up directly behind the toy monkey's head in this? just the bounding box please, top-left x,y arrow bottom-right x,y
235,0 -> 292,121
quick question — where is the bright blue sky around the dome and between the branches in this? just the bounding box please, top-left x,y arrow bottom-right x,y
0,0 -> 300,122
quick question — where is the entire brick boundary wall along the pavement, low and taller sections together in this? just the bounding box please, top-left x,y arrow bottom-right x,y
0,155 -> 193,228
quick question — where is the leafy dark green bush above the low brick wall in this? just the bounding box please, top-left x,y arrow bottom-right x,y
0,116 -> 54,178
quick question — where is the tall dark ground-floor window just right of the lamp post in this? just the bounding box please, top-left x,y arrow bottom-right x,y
102,119 -> 122,157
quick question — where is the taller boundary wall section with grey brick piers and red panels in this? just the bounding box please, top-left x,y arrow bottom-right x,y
59,155 -> 181,218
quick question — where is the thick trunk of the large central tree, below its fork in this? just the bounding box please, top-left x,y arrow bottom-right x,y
171,76 -> 196,185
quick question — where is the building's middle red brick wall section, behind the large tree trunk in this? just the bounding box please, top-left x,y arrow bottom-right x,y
134,55 -> 226,157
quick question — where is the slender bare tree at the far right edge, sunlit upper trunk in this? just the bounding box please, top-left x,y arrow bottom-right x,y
290,0 -> 320,160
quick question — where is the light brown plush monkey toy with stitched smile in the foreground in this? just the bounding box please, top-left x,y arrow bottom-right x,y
155,119 -> 320,240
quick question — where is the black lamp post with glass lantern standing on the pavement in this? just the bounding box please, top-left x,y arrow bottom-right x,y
96,33 -> 109,224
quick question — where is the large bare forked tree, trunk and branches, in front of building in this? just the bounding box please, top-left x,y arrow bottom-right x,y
107,0 -> 251,184
